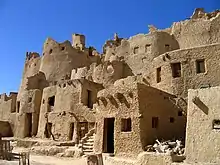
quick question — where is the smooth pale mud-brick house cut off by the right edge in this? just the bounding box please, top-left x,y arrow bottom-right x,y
185,86 -> 220,164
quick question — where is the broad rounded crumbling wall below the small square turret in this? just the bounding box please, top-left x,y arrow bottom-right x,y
40,38 -> 99,82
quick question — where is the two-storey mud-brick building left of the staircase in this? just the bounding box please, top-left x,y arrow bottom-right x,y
38,79 -> 103,143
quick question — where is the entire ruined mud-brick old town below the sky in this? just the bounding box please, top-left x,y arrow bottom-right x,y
0,8 -> 220,165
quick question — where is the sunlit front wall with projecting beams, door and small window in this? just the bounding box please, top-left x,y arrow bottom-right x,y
94,80 -> 142,157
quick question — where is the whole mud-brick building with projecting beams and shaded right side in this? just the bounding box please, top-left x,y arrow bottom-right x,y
94,77 -> 186,156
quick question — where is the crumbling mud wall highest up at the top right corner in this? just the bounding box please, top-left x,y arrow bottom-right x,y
171,8 -> 220,49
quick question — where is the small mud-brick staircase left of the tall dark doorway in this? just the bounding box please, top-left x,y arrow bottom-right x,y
79,129 -> 95,155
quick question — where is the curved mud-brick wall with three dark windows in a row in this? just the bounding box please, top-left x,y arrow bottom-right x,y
150,44 -> 220,98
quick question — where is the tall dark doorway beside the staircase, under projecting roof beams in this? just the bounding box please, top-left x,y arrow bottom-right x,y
103,118 -> 115,153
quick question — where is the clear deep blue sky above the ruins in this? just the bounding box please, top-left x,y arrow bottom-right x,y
0,0 -> 220,93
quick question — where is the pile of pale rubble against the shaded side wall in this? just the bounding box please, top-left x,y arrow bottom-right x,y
145,140 -> 184,155
